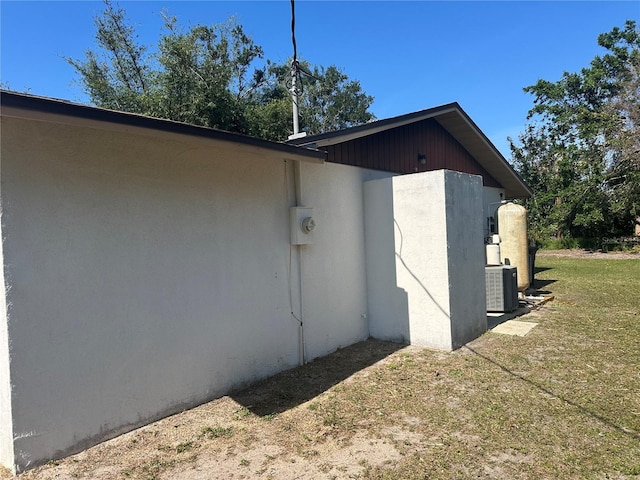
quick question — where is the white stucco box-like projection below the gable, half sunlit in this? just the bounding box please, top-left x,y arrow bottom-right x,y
365,170 -> 486,350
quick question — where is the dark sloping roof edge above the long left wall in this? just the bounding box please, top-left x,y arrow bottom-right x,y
0,91 -> 326,163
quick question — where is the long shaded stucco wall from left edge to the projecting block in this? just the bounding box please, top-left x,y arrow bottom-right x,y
0,118 -> 368,469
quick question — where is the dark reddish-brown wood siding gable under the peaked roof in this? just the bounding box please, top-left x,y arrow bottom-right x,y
326,119 -> 502,188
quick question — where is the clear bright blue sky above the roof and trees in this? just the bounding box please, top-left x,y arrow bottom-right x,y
0,0 -> 640,158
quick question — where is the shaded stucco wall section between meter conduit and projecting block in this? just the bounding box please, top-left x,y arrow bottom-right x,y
300,163 -> 369,360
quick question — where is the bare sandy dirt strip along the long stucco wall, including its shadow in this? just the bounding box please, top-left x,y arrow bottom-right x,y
12,341 -> 422,480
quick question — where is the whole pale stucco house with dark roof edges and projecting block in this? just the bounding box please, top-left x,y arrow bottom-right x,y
0,91 -> 528,471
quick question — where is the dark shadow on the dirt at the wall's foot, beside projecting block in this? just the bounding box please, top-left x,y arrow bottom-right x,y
231,339 -> 406,417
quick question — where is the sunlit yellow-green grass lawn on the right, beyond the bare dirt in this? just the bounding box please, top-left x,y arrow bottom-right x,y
352,257 -> 640,479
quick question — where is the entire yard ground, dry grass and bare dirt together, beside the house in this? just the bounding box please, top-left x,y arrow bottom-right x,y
16,255 -> 640,480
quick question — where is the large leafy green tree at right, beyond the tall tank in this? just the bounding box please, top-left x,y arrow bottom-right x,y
511,21 -> 640,239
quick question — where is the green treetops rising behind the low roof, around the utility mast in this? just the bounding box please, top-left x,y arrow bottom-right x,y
66,0 -> 375,140
